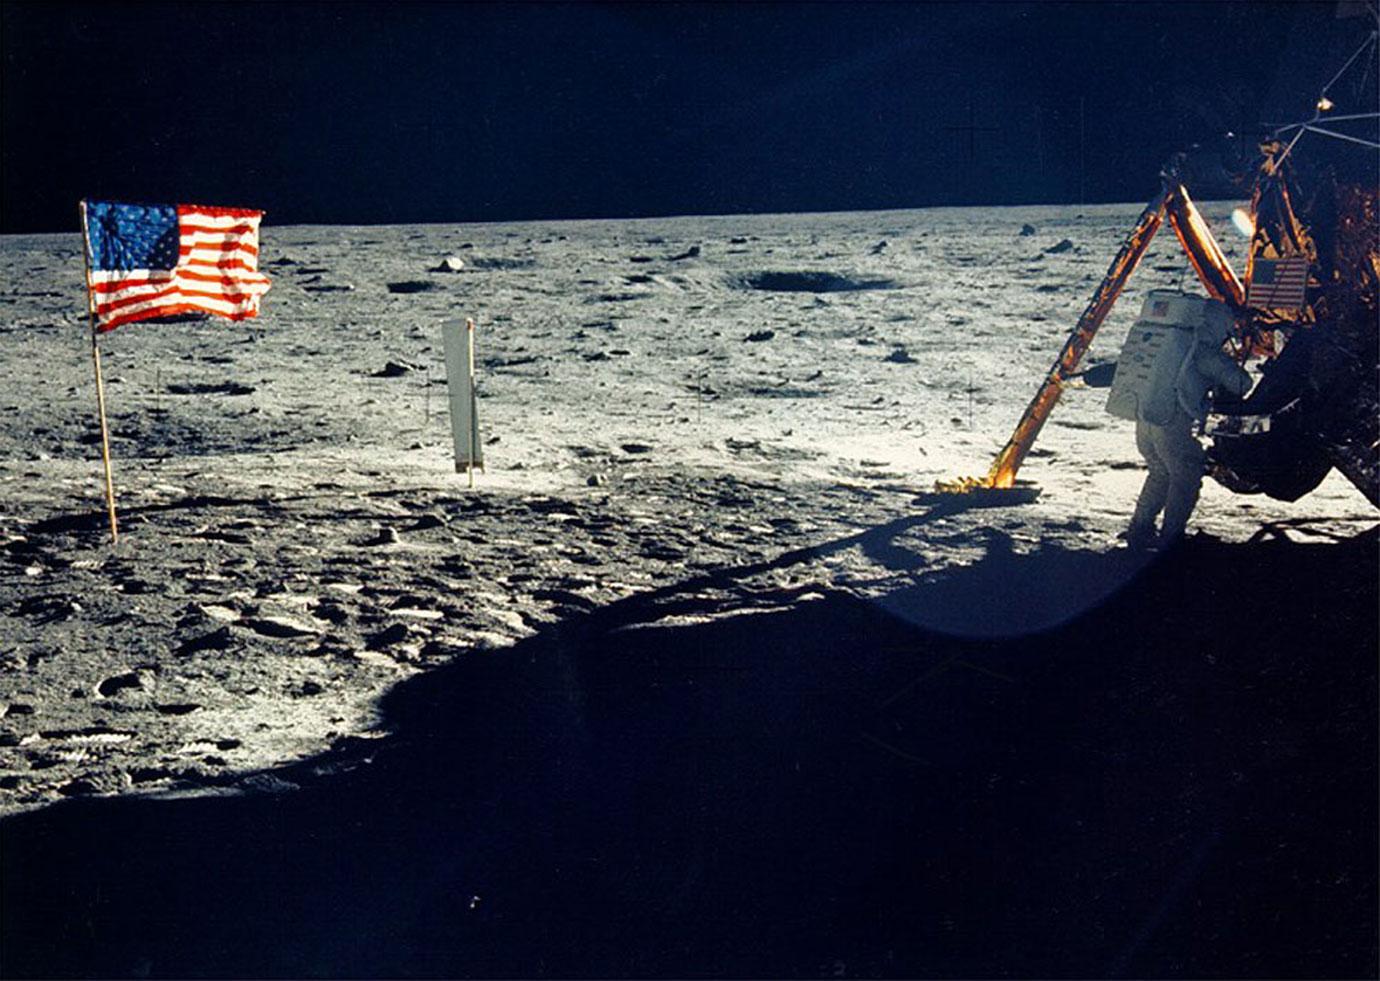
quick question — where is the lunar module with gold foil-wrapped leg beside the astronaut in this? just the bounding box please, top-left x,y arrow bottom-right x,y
937,20 -> 1380,506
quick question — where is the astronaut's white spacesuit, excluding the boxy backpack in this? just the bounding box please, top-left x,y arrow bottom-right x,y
1126,302 -> 1250,545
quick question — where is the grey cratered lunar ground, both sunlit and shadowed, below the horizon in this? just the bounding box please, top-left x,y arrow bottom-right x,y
0,203 -> 1377,977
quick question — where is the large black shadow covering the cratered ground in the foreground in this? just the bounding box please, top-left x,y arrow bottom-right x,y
0,533 -> 1380,977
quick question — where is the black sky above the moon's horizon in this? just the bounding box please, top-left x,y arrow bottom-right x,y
0,1 -> 1373,232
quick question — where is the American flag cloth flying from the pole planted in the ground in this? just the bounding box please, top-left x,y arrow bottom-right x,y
81,201 -> 269,331
